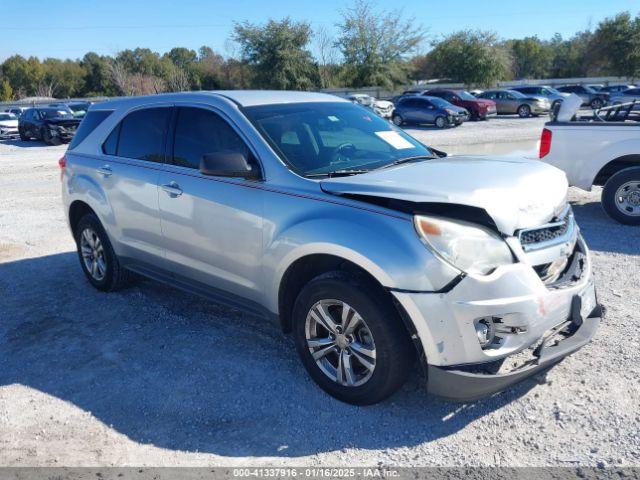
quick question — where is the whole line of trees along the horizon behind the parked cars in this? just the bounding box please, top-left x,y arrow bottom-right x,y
0,0 -> 640,101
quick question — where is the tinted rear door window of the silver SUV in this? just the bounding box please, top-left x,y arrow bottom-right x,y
114,107 -> 171,163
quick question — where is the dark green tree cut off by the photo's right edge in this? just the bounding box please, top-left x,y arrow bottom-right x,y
589,12 -> 640,78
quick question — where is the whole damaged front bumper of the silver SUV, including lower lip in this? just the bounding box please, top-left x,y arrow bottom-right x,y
392,233 -> 601,401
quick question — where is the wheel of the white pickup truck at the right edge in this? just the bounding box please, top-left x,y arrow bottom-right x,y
602,167 -> 640,225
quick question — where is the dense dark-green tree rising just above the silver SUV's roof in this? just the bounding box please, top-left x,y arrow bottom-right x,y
233,18 -> 319,90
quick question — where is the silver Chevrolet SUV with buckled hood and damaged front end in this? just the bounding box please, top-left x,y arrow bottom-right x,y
60,91 -> 600,404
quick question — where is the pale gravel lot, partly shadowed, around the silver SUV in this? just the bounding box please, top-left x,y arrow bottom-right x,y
0,119 -> 640,467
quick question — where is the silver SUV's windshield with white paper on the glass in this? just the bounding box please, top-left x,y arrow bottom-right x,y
244,102 -> 434,176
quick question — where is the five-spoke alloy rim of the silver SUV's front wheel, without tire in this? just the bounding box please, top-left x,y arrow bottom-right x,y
305,300 -> 376,387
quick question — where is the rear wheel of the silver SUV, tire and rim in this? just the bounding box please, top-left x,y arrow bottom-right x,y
74,213 -> 130,292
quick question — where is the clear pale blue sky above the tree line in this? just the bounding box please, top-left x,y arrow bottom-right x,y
0,0 -> 640,60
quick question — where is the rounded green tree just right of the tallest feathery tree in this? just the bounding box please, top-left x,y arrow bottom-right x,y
430,30 -> 509,87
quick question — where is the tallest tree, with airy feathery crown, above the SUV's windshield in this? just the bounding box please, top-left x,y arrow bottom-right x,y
336,0 -> 424,89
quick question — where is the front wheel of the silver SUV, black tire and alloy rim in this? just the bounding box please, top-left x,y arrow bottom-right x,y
293,272 -> 415,405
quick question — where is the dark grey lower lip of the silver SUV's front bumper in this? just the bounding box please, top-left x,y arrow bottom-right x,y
427,304 -> 602,402
